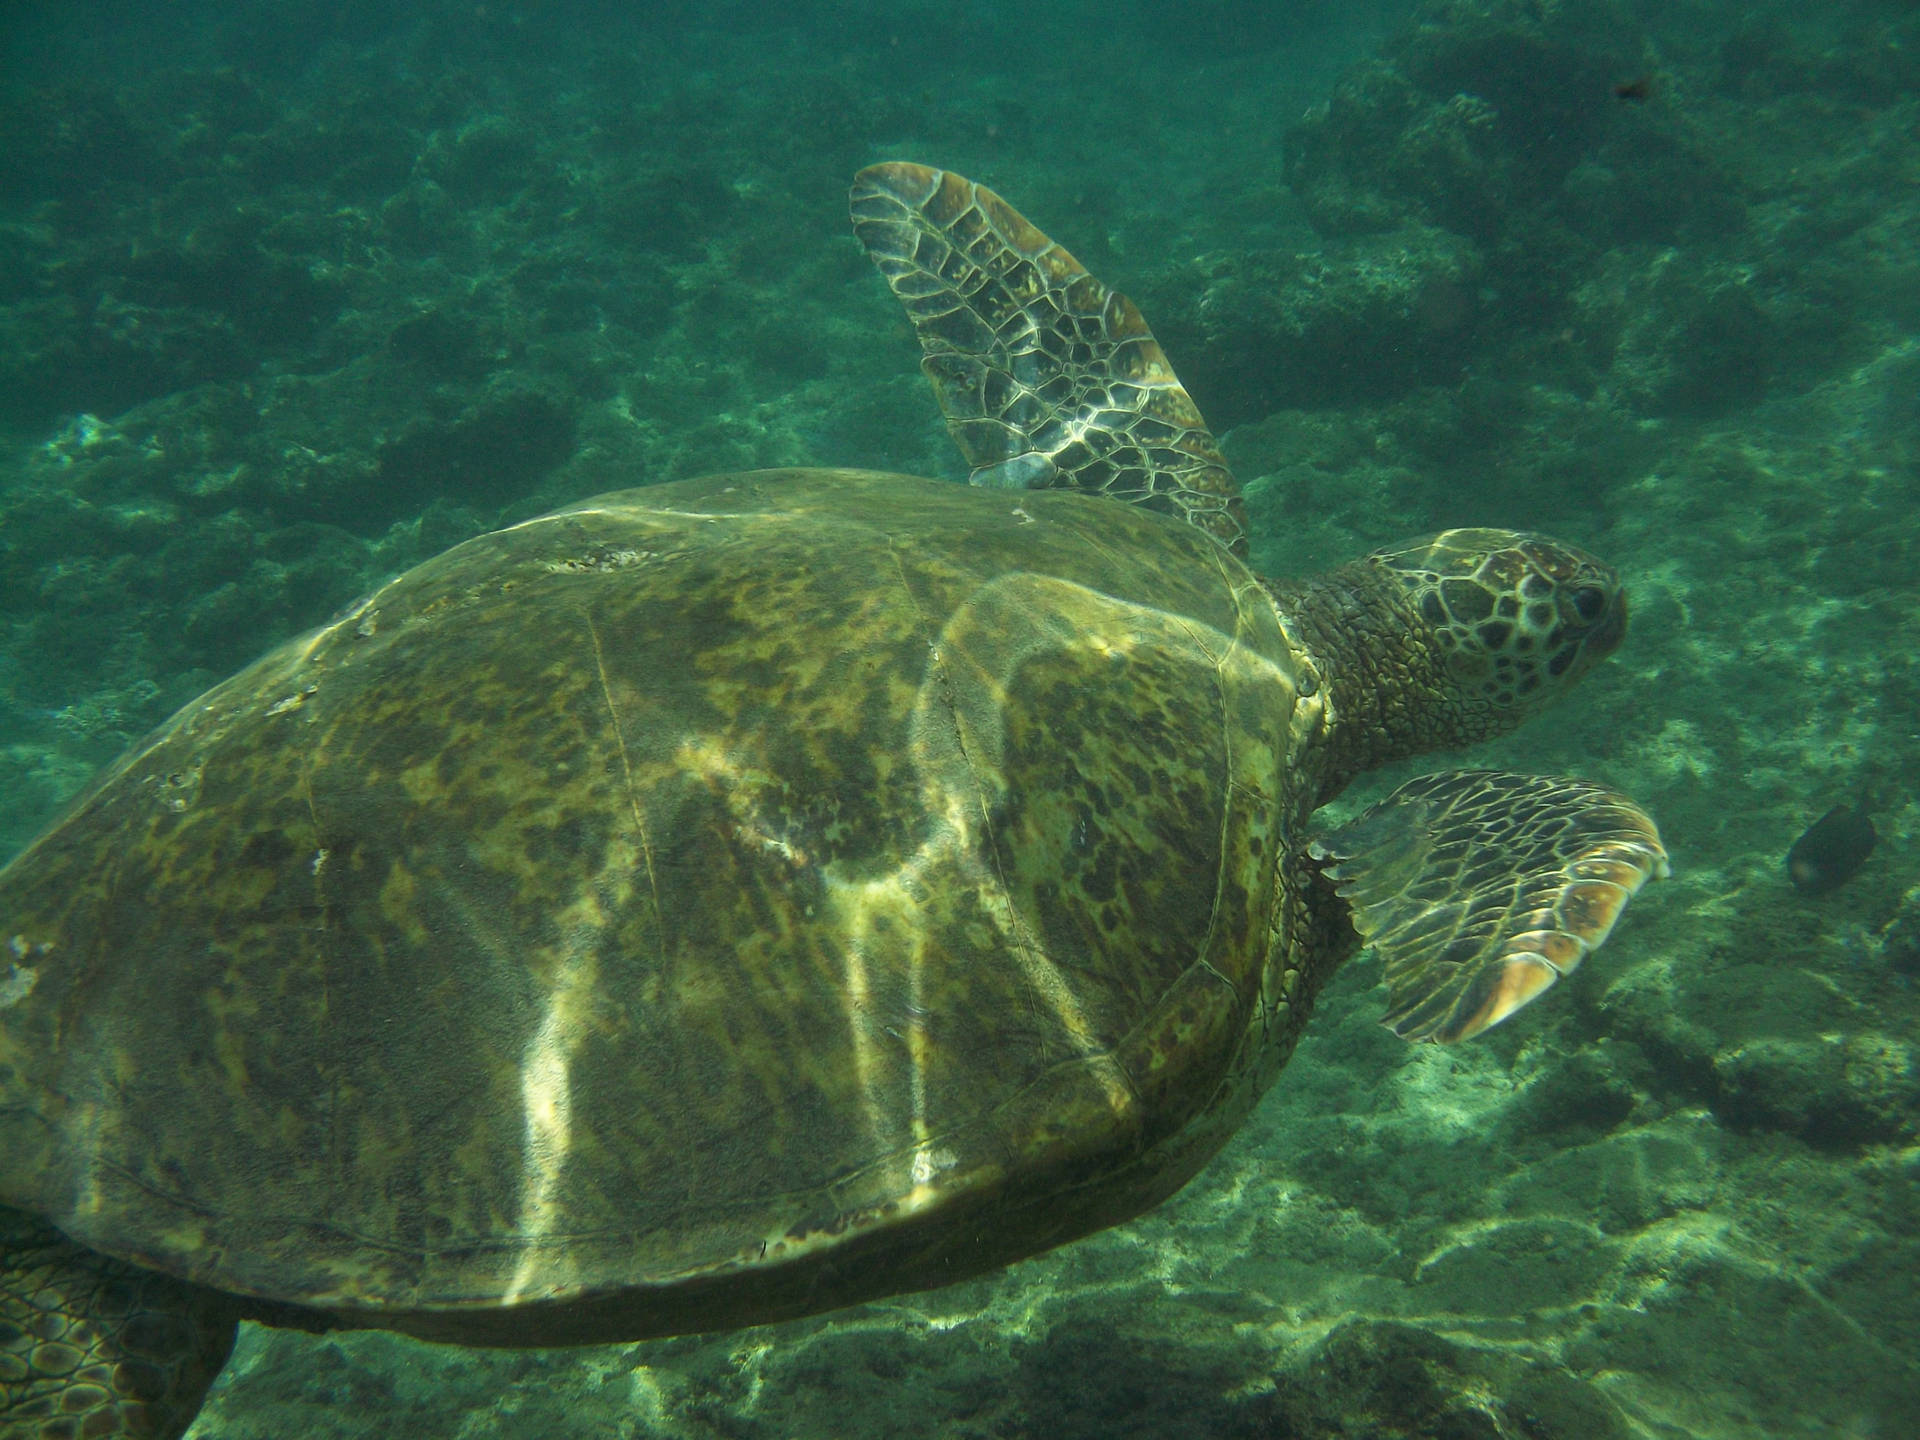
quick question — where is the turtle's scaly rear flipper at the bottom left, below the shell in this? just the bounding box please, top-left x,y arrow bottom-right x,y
0,1206 -> 238,1440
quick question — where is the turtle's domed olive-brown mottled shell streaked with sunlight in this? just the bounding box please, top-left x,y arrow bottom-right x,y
0,470 -> 1319,1342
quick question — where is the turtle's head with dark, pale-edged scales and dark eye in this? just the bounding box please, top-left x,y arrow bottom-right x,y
1369,530 -> 1626,743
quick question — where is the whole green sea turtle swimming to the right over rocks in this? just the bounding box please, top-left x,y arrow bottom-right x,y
0,165 -> 1665,1440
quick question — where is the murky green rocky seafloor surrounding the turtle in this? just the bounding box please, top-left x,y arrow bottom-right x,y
0,0 -> 1920,1440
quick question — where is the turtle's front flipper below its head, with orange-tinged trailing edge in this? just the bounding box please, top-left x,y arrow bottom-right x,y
1311,770 -> 1667,1041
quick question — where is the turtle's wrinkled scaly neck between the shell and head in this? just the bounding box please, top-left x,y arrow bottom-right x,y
1261,557 -> 1474,804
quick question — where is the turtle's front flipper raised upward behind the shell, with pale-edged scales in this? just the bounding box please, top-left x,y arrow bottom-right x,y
851,161 -> 1246,555
